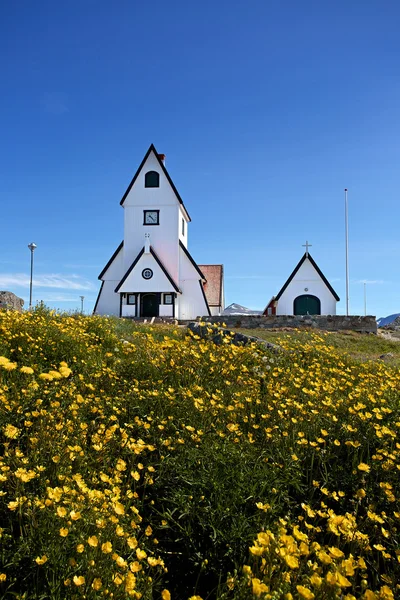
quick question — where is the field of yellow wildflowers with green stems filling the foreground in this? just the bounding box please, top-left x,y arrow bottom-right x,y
0,308 -> 400,600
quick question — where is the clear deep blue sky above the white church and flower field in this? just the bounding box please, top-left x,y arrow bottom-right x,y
0,0 -> 400,317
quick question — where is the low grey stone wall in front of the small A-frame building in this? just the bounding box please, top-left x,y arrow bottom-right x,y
201,315 -> 377,333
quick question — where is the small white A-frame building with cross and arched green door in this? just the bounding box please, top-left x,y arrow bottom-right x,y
263,250 -> 340,315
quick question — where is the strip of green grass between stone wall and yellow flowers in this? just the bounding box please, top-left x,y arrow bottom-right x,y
235,329 -> 400,366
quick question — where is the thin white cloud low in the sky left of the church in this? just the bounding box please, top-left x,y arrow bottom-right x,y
0,273 -> 96,290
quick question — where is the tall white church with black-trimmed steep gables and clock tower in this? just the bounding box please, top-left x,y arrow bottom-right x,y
93,144 -> 224,320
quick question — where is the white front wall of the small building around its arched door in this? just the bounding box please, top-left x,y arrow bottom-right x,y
276,258 -> 336,315
